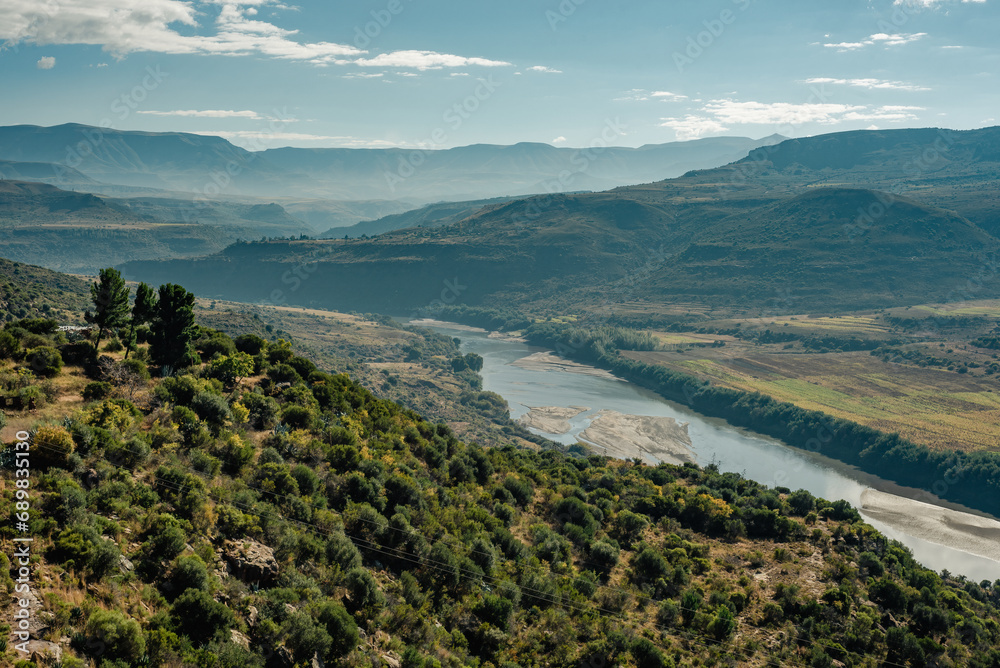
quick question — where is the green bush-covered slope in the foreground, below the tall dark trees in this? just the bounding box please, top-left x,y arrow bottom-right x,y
0,290 -> 1000,668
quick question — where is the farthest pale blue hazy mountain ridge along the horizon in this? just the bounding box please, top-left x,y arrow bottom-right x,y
0,123 -> 781,201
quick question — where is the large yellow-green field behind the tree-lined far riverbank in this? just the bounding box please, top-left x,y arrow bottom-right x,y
626,350 -> 1000,451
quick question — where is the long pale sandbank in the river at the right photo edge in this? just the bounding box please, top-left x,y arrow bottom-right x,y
860,489 -> 1000,562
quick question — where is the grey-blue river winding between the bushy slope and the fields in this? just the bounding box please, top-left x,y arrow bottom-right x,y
415,322 -> 1000,582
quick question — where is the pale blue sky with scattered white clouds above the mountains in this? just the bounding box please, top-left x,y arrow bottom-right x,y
0,0 -> 1000,150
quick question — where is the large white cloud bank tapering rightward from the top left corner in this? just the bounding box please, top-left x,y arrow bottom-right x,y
0,0 -> 507,69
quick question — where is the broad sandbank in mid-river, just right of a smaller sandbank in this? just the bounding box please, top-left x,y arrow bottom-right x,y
580,410 -> 695,464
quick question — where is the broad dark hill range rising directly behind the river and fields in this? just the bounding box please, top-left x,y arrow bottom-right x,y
121,129 -> 1000,312
